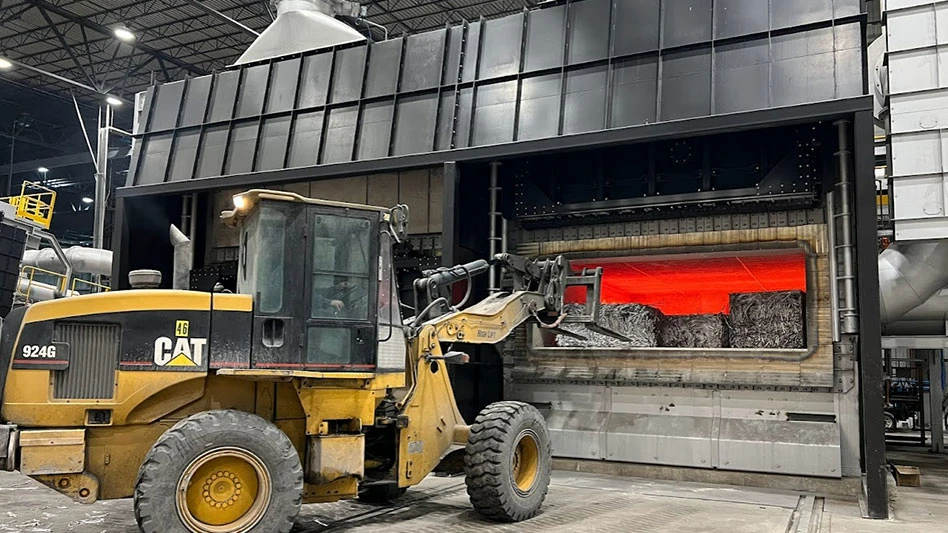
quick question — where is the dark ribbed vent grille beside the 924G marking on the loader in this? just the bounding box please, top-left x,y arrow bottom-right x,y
53,322 -> 121,400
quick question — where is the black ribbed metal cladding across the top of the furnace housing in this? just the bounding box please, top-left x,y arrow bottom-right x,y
129,0 -> 865,186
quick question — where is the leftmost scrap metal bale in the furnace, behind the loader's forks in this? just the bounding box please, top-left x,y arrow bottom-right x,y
556,304 -> 662,348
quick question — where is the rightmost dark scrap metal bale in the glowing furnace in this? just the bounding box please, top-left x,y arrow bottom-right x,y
728,291 -> 806,349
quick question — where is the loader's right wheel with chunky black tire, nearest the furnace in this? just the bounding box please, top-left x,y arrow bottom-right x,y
464,402 -> 552,522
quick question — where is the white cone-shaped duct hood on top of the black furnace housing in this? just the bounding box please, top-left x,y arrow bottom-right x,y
234,0 -> 366,65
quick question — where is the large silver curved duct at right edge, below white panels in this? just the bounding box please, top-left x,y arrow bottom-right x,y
879,241 -> 948,324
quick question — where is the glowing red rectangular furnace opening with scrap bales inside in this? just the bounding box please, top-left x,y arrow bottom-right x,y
535,248 -> 807,350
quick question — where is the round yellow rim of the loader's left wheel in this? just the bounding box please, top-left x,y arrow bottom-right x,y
176,448 -> 271,533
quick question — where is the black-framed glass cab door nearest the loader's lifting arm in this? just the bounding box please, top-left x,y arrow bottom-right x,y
301,206 -> 380,372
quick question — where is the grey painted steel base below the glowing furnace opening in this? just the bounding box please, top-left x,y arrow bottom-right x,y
513,384 -> 842,478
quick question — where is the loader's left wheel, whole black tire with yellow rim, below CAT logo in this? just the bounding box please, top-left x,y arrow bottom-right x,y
135,410 -> 303,533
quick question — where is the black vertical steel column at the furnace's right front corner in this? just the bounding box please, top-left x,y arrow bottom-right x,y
853,110 -> 889,518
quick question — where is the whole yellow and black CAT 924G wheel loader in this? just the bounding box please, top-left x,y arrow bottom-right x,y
0,190 -> 624,533
